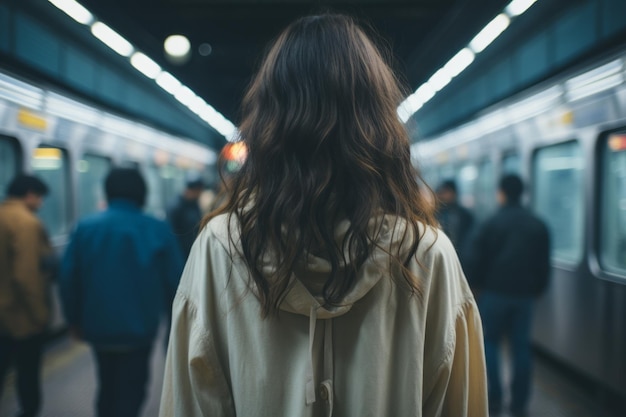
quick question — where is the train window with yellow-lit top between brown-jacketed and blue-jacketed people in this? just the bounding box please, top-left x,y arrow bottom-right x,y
31,146 -> 71,236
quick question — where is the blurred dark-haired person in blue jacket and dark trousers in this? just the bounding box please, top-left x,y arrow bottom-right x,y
60,168 -> 183,417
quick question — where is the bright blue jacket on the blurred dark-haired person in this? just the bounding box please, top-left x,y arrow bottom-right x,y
60,200 -> 183,348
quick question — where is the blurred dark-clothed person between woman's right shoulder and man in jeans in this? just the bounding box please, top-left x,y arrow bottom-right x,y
437,180 -> 474,263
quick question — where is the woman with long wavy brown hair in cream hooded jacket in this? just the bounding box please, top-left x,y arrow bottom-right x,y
160,15 -> 487,417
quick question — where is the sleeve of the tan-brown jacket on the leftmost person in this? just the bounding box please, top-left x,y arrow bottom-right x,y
15,216 -> 51,327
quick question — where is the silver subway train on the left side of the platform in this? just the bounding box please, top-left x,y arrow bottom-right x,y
0,72 -> 217,331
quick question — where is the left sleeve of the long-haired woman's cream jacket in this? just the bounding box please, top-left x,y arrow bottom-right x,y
159,292 -> 235,417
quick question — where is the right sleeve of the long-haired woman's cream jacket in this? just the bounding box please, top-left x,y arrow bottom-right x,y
422,232 -> 489,417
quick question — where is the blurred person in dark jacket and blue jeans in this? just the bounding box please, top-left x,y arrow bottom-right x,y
467,174 -> 550,416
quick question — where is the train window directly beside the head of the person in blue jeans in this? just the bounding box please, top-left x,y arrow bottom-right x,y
532,142 -> 584,264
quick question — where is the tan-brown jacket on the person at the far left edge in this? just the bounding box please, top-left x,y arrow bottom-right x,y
0,198 -> 52,339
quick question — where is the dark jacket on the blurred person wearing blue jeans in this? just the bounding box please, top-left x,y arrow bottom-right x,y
466,204 -> 550,296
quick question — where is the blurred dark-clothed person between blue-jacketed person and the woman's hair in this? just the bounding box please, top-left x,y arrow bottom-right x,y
167,179 -> 204,259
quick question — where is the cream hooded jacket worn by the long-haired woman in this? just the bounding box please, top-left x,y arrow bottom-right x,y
160,215 -> 488,417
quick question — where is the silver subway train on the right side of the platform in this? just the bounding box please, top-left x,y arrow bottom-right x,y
411,50 -> 626,399
